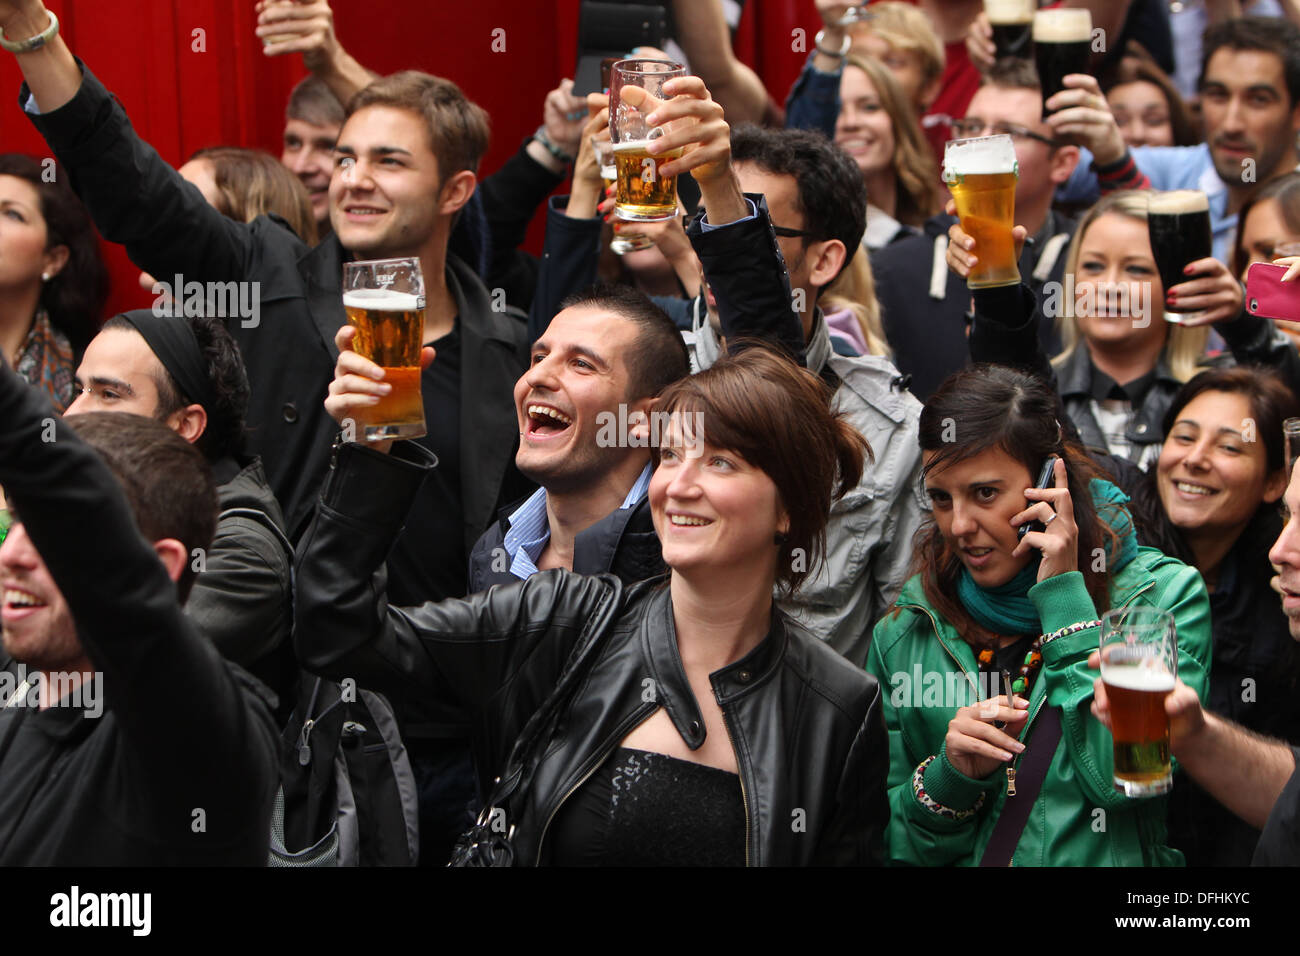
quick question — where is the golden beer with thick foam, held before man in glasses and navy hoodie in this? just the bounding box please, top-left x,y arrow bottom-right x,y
944,135 -> 1021,289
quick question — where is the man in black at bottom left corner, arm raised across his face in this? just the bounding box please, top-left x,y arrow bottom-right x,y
0,367 -> 278,866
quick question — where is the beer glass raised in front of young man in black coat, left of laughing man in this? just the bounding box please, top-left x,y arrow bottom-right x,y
343,259 -> 425,441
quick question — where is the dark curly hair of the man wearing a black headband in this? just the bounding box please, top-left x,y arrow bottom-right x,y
104,315 -> 248,462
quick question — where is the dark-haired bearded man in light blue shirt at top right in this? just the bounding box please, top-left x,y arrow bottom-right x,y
1048,17 -> 1300,263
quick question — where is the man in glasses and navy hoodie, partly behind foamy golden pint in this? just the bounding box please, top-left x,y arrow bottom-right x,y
871,60 -> 1079,401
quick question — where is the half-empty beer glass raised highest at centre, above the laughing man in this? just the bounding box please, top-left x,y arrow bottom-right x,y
610,60 -> 686,222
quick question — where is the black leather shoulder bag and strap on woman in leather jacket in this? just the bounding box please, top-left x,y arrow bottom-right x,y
447,628 -> 606,866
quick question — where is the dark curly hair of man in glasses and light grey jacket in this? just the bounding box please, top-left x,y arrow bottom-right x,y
732,124 -> 867,294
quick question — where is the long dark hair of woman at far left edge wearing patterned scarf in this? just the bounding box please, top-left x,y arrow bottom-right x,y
0,152 -> 108,354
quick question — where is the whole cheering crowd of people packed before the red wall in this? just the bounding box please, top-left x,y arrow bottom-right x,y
0,0 -> 1300,866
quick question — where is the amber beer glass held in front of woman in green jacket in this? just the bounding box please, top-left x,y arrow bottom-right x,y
1101,607 -> 1178,797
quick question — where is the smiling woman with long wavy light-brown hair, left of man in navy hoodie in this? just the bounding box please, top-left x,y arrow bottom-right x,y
835,55 -> 941,250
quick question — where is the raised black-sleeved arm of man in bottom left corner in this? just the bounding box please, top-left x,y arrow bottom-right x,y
0,367 -> 276,847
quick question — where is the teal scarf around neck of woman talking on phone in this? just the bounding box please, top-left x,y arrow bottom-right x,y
957,479 -> 1138,636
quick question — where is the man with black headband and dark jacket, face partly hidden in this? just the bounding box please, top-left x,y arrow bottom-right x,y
65,310 -> 294,706
